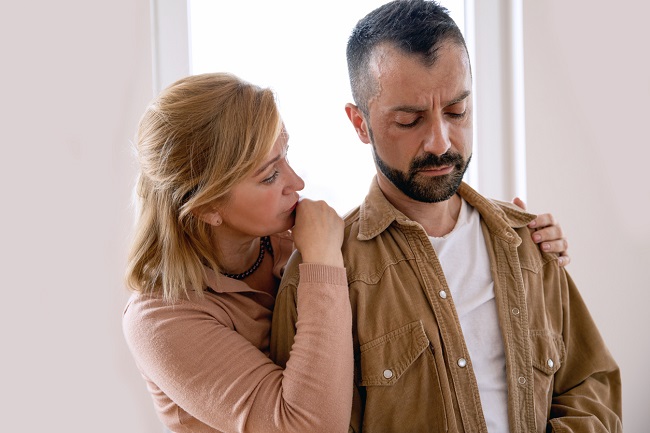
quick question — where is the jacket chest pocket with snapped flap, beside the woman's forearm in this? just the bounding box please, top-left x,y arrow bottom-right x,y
359,321 -> 447,433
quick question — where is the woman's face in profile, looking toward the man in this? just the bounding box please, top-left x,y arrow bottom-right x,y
214,128 -> 305,237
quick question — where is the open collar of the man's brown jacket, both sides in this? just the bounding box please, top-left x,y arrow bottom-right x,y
358,176 -> 535,245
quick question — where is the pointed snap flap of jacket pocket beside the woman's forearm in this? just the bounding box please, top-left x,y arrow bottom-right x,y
359,321 -> 429,386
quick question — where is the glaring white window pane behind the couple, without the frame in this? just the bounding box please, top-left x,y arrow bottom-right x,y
189,0 -> 464,214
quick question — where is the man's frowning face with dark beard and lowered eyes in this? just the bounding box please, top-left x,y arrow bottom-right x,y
350,43 -> 472,202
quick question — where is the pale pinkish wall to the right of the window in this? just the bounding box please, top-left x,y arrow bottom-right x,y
524,0 -> 650,433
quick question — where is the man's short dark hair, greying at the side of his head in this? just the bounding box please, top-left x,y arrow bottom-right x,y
347,0 -> 467,115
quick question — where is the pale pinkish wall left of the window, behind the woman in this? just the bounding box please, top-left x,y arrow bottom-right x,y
0,0 -> 162,433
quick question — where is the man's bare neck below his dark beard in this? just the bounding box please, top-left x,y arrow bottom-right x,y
377,176 -> 461,237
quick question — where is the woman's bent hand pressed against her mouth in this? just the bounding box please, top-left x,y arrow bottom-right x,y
292,198 -> 344,267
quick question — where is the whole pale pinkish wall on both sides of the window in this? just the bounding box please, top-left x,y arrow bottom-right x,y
0,0 -> 650,433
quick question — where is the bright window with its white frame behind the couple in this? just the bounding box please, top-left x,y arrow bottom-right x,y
151,0 -> 526,208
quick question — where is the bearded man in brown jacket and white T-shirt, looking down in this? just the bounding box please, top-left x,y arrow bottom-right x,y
272,0 -> 621,433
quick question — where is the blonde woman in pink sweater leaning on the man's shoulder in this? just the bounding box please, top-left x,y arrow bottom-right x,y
123,74 -> 563,433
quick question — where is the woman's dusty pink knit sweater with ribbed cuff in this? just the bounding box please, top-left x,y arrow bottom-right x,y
123,235 -> 353,433
